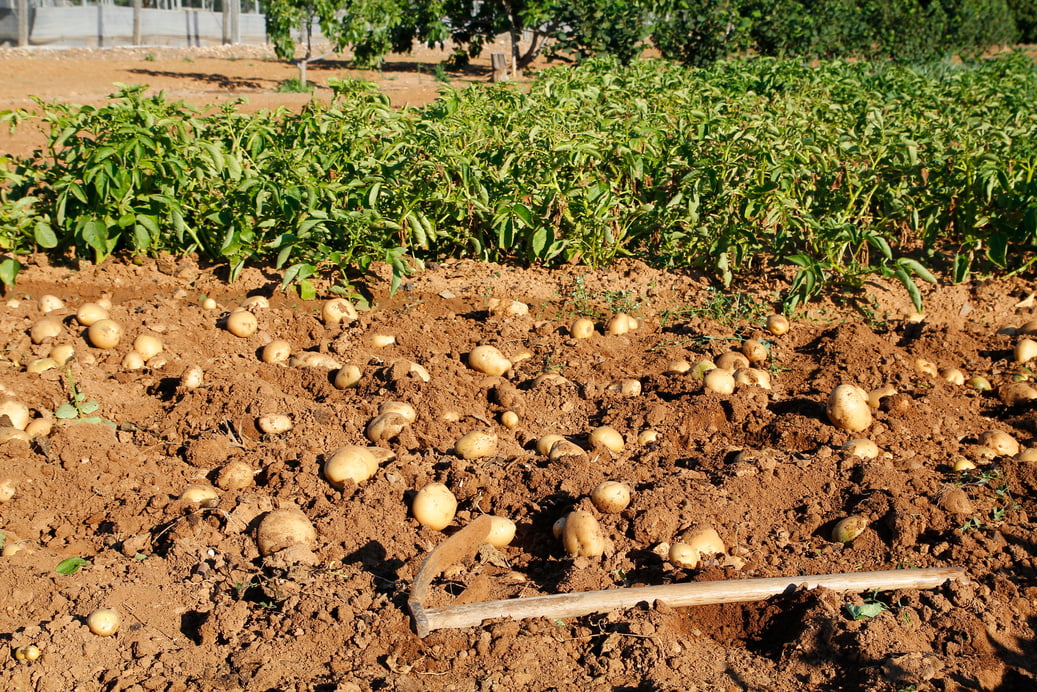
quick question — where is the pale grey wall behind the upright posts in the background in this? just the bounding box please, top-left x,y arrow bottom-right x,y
0,5 -> 267,48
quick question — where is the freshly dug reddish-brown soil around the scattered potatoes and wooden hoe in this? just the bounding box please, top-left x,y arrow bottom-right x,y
0,45 -> 1037,692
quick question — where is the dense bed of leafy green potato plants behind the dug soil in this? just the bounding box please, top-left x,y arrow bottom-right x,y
0,53 -> 1037,307
